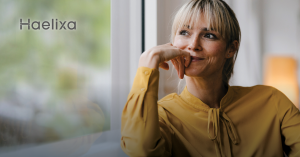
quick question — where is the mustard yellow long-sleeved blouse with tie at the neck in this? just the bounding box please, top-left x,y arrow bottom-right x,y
121,67 -> 300,157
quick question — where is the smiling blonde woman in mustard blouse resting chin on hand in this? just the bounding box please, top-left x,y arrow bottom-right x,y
121,0 -> 300,157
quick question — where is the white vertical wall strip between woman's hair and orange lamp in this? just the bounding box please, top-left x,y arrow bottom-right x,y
228,0 -> 263,86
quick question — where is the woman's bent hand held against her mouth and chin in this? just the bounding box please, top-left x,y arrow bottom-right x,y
139,43 -> 191,79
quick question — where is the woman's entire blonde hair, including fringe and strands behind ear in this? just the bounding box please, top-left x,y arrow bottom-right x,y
171,0 -> 241,83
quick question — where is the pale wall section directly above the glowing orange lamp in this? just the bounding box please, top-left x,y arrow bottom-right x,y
262,0 -> 300,87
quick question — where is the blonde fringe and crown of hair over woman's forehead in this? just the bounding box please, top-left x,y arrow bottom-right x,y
170,0 -> 237,43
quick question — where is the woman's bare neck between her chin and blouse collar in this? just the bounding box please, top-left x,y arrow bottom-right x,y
186,75 -> 227,108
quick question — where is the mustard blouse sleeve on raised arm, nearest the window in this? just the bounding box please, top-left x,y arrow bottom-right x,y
121,67 -> 172,156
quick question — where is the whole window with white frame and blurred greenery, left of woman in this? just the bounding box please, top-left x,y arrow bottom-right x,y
0,0 -> 141,157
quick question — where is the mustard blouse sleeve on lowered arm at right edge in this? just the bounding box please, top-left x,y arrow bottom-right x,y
274,90 -> 300,157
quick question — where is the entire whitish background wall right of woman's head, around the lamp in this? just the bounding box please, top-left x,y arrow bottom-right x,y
227,0 -> 300,86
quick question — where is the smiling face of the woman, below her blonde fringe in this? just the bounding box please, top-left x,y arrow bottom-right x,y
173,17 -> 233,77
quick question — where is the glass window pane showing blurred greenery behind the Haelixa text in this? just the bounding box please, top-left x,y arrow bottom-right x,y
0,0 -> 111,153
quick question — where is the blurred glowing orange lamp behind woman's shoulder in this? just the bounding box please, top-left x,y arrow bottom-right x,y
264,56 -> 299,108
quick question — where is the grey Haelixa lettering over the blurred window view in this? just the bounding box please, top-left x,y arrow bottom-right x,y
20,19 -> 76,30
